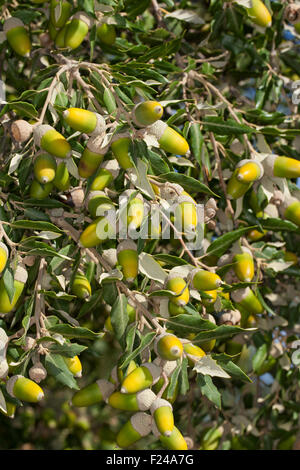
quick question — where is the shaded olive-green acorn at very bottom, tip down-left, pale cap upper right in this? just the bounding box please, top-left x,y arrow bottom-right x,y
116,411 -> 152,449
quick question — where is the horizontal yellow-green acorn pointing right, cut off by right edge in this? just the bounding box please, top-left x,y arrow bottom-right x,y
263,155 -> 300,178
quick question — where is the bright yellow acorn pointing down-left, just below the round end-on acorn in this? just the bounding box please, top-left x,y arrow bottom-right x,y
121,362 -> 162,393
